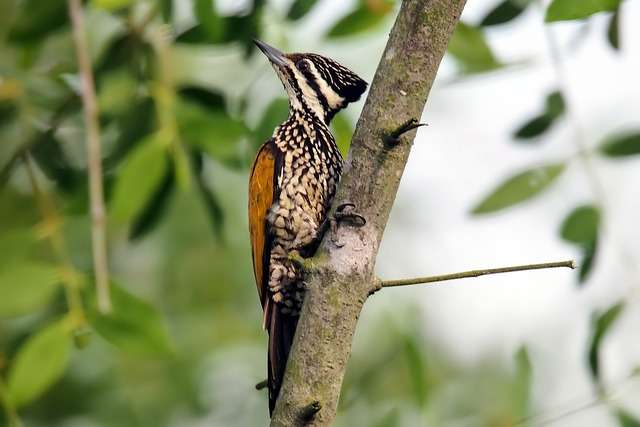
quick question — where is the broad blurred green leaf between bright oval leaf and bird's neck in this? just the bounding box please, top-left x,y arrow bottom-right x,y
176,101 -> 249,166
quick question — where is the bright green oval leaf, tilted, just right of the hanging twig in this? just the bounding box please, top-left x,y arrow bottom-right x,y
111,135 -> 167,222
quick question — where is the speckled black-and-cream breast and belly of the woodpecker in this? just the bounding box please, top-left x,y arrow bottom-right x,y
268,111 -> 342,315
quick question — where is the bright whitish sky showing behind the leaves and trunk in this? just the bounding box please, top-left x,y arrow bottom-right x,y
175,0 -> 640,427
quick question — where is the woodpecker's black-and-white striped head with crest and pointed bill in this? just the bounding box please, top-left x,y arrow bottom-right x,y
254,40 -> 367,124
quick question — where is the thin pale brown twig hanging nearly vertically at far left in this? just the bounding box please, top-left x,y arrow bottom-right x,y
68,0 -> 111,313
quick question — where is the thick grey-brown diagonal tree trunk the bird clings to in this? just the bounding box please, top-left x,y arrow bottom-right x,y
271,0 -> 465,426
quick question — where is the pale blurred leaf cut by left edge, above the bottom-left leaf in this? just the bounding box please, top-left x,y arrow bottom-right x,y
0,261 -> 60,317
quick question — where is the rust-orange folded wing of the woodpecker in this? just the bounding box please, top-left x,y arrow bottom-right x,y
249,140 -> 276,309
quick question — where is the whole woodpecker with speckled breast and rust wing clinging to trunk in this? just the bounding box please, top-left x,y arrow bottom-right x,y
248,40 -> 367,415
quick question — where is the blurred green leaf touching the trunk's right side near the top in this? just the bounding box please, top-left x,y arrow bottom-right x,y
447,21 -> 501,74
